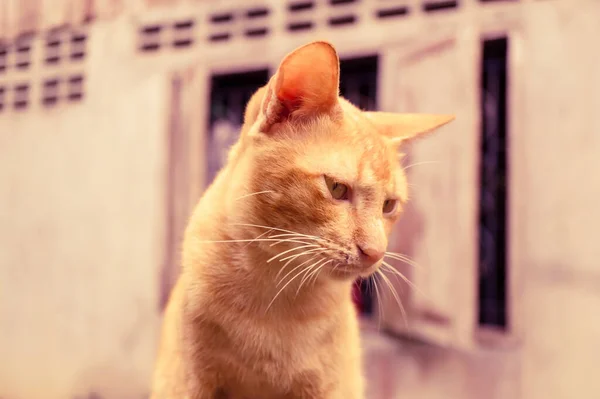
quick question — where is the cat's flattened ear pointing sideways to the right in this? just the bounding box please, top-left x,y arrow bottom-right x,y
364,112 -> 455,145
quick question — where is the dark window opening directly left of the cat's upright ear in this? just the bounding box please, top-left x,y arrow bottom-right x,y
206,69 -> 269,183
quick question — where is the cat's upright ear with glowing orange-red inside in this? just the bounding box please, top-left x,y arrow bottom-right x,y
262,42 -> 340,126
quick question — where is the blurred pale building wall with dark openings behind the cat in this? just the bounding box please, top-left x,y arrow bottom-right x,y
0,0 -> 600,399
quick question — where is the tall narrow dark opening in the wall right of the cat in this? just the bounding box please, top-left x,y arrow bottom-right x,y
479,38 -> 509,328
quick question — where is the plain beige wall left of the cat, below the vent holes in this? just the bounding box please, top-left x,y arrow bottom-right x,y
0,21 -> 168,399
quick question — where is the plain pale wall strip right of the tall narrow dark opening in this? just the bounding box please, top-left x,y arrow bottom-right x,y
513,2 -> 600,398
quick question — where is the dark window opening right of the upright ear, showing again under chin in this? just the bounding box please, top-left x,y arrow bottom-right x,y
340,56 -> 380,315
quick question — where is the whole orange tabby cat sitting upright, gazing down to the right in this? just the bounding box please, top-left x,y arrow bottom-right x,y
152,42 -> 453,399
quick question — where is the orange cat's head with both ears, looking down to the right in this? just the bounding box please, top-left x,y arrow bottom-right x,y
235,42 -> 453,278
